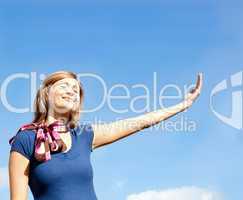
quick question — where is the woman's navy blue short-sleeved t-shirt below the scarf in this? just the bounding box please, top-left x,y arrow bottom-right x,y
10,124 -> 97,200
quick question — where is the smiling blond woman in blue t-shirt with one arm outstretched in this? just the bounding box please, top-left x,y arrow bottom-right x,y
9,71 -> 202,200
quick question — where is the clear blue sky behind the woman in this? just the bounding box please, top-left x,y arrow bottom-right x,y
0,0 -> 243,200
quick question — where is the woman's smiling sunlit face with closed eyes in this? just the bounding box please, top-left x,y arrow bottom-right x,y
48,78 -> 80,113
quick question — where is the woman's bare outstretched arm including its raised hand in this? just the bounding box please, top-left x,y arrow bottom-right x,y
92,73 -> 202,149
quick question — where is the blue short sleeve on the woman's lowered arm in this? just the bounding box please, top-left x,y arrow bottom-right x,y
10,131 -> 34,160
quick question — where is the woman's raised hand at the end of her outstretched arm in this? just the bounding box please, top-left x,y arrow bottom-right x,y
183,73 -> 203,109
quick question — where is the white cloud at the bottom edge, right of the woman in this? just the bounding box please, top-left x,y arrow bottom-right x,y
127,186 -> 223,200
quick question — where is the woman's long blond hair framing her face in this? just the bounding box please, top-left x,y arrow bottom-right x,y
32,71 -> 84,128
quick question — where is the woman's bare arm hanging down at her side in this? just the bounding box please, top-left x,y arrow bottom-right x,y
8,151 -> 29,200
